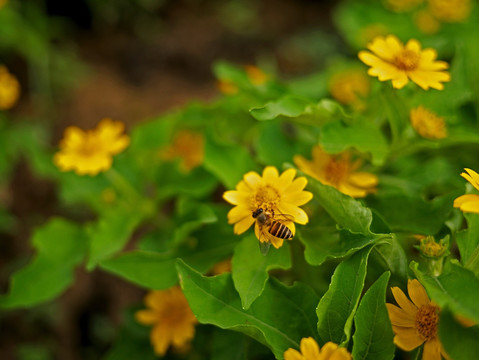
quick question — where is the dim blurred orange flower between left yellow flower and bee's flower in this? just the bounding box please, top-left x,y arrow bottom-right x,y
163,130 -> 205,172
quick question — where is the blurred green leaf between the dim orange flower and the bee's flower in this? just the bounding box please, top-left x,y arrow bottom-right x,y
203,131 -> 257,189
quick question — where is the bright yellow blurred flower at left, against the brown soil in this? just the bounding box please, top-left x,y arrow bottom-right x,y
53,118 -> 130,176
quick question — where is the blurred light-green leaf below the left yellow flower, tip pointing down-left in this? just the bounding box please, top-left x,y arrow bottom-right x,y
87,207 -> 144,270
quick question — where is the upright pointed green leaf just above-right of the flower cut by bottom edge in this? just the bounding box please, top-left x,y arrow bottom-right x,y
316,246 -> 373,346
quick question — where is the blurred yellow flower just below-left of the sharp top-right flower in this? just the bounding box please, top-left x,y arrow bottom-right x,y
329,69 -> 371,109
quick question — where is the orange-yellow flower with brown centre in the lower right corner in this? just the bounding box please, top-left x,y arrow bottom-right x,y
386,279 -> 449,360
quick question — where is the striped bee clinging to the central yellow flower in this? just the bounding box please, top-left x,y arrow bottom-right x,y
252,208 -> 294,255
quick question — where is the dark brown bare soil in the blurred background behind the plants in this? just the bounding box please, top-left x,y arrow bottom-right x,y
0,0 -> 335,360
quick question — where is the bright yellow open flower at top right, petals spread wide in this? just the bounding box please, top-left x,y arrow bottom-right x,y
358,35 -> 451,90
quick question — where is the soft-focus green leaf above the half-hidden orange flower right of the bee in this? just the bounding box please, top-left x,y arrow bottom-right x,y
319,119 -> 389,166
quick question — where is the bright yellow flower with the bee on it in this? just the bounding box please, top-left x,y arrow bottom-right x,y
223,166 -> 313,248
